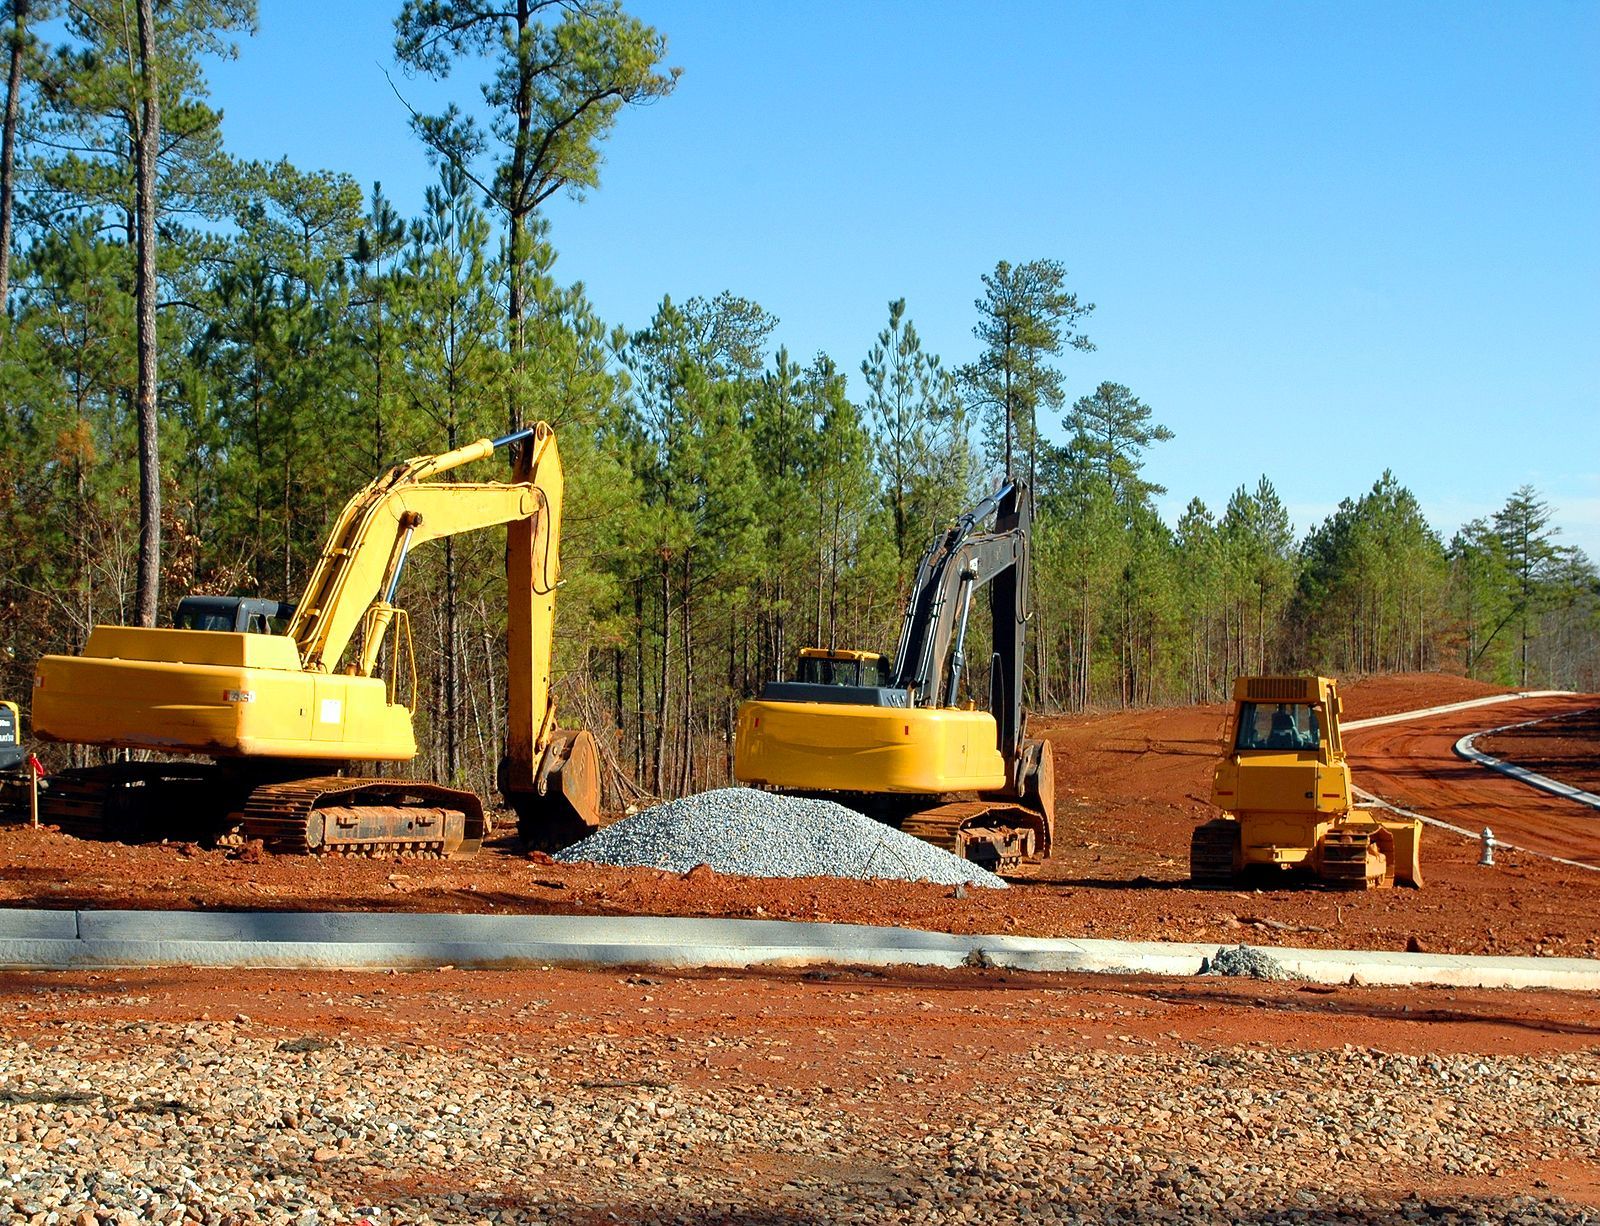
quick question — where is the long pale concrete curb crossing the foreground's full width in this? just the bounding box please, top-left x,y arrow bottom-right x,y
0,911 -> 1600,991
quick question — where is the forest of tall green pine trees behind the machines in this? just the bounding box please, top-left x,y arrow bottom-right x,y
0,0 -> 1600,800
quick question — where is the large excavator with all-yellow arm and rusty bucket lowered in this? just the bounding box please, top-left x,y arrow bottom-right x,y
32,423 -> 600,856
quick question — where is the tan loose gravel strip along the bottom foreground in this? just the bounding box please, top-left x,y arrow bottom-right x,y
0,1024 -> 1600,1226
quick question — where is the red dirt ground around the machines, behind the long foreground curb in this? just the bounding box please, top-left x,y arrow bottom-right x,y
0,675 -> 1600,957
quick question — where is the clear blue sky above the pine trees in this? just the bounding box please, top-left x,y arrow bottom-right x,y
203,0 -> 1600,559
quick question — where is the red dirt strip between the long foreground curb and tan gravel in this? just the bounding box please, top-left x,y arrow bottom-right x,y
0,968 -> 1600,1204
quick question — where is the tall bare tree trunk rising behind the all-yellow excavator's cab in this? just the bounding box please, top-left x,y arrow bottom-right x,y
134,0 -> 162,626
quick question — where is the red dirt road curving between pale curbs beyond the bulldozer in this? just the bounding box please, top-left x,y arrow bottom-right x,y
1346,695 -> 1600,870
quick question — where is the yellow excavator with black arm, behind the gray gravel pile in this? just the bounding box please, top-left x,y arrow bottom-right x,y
733,482 -> 1054,867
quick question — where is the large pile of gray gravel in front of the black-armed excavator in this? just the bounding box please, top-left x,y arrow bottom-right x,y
555,787 -> 1005,888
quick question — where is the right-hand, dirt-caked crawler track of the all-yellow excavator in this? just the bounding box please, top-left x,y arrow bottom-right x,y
242,776 -> 488,858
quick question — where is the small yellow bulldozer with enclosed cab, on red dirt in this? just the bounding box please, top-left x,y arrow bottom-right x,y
1189,677 -> 1422,890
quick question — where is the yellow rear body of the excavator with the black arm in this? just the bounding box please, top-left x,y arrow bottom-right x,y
733,699 -> 1008,795
